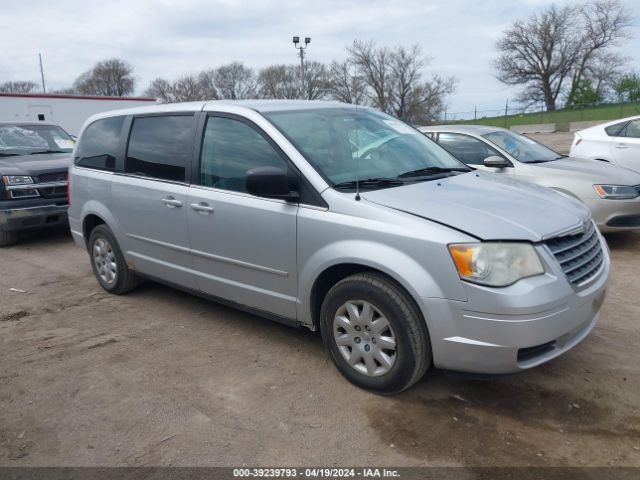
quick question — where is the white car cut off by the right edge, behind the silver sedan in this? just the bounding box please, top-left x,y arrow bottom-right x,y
570,116 -> 640,171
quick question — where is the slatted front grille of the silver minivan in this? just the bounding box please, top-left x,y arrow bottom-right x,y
545,222 -> 604,286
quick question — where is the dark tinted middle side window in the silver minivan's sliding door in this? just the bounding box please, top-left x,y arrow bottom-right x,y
125,115 -> 194,182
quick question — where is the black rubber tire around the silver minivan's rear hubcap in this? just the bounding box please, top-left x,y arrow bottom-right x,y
88,225 -> 140,295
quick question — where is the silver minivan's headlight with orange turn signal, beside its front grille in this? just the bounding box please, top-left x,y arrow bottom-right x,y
449,242 -> 544,287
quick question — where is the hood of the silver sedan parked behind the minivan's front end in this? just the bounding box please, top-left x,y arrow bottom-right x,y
530,157 -> 640,186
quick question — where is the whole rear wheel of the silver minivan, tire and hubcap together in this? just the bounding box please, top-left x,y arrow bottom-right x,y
89,225 -> 139,295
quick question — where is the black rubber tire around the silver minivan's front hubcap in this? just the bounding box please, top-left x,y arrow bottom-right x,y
320,272 -> 431,394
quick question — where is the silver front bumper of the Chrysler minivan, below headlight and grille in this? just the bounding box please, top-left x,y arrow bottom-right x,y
420,231 -> 610,374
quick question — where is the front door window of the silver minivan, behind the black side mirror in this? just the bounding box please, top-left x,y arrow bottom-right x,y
200,117 -> 287,192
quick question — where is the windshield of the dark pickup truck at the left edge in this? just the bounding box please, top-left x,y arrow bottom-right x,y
0,123 -> 74,157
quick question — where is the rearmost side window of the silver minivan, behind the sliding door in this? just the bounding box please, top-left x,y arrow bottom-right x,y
74,117 -> 124,172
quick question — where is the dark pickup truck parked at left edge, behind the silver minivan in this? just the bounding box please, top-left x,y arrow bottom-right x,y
0,122 -> 74,247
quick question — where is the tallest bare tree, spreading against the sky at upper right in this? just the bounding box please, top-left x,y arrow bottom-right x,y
494,0 -> 631,110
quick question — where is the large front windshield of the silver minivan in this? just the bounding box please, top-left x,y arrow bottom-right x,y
265,108 -> 470,189
